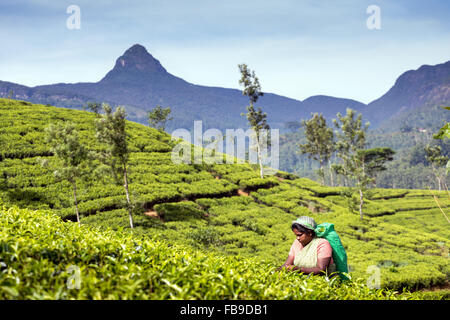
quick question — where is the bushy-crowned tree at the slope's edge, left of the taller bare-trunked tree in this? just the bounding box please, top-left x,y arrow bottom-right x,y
299,113 -> 334,185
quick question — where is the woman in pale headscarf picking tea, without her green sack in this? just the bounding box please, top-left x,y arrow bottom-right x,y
278,216 -> 336,274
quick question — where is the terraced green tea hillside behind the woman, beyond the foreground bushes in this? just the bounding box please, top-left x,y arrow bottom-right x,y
0,99 -> 450,297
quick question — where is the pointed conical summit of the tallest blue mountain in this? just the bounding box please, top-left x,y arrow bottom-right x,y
102,44 -> 167,81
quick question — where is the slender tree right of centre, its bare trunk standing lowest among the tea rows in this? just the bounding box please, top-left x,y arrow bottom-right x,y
333,108 -> 374,220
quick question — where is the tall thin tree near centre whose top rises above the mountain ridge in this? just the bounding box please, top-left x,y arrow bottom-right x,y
238,64 -> 270,178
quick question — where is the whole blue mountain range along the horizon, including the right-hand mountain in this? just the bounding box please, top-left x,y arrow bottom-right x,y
0,44 -> 450,131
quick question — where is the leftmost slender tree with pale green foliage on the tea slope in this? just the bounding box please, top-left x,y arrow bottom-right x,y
42,123 -> 90,225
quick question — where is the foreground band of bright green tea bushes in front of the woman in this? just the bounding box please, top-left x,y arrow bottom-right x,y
0,206 -> 428,300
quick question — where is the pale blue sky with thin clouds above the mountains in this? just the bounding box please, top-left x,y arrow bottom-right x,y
0,0 -> 450,103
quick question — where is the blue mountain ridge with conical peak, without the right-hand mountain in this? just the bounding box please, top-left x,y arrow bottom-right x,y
0,44 -> 365,131
